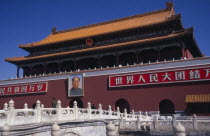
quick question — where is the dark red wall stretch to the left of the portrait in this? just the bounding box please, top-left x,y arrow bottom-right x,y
0,80 -> 69,109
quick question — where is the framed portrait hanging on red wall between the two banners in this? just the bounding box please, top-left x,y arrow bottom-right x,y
67,74 -> 84,97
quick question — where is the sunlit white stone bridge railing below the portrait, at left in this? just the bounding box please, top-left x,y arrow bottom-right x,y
0,100 -> 151,127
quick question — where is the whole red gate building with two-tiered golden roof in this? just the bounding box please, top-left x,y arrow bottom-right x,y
0,2 -> 210,114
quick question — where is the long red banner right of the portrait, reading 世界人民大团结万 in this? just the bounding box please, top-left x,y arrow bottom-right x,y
109,67 -> 210,87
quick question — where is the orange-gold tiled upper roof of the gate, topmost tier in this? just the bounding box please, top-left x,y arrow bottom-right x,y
19,2 -> 174,48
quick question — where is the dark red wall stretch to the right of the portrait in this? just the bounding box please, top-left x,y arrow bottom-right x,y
84,76 -> 210,111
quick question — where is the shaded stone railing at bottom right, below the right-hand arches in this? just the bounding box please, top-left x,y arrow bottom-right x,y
119,115 -> 210,135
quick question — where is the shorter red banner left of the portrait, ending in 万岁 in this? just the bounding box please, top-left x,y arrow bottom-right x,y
0,82 -> 47,96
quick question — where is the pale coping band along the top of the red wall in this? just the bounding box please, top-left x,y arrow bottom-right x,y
0,57 -> 210,85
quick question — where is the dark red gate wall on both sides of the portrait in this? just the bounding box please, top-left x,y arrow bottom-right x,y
0,76 -> 210,111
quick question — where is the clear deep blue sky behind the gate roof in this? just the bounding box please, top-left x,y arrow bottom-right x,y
0,0 -> 210,80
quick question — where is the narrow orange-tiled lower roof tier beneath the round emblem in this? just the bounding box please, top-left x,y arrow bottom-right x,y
5,28 -> 193,63
